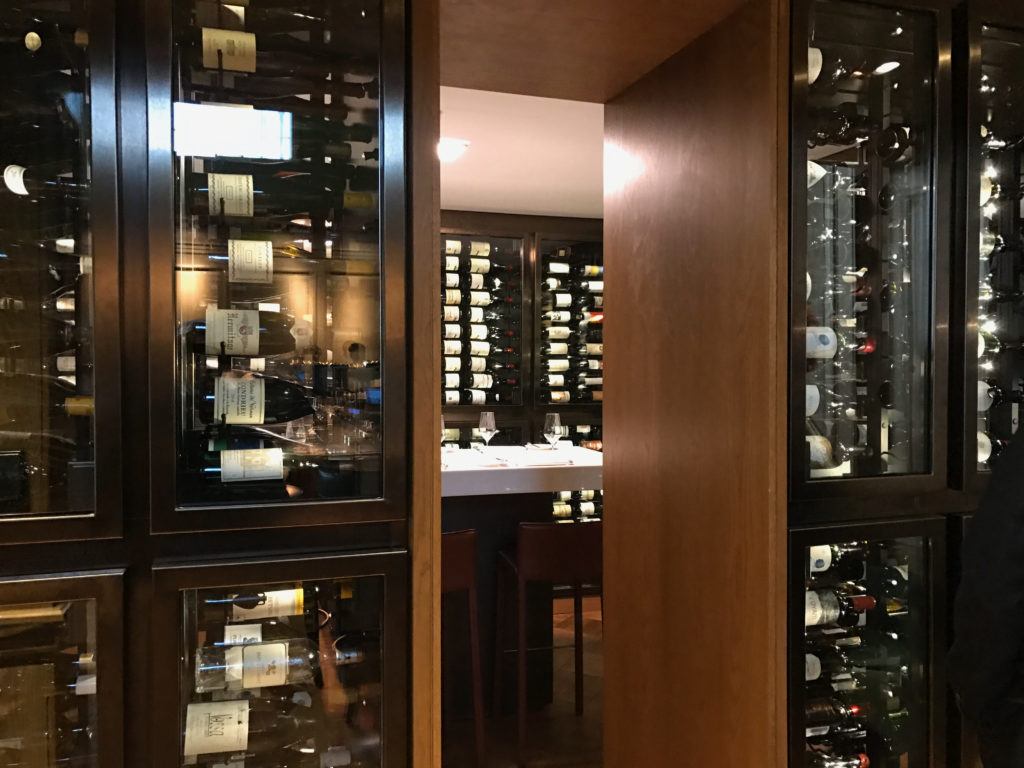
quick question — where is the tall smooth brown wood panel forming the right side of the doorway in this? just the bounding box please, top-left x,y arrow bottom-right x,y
604,0 -> 787,768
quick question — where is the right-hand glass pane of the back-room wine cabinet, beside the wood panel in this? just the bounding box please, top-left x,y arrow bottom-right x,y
537,240 -> 604,404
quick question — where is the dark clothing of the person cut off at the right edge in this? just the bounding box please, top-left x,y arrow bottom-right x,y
949,439 -> 1024,768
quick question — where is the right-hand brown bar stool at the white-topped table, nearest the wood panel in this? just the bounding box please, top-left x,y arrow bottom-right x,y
494,521 -> 603,765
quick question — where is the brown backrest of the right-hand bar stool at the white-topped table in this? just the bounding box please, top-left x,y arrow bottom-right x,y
516,520 -> 603,584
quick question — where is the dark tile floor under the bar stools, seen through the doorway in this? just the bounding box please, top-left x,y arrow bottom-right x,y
442,598 -> 604,768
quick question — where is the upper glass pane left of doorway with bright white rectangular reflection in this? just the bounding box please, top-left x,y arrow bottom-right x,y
173,0 -> 383,512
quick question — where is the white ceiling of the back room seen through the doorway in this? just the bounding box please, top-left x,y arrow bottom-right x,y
441,87 -> 604,218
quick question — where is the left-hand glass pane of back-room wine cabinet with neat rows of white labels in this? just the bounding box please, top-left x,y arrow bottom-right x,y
441,234 -> 522,406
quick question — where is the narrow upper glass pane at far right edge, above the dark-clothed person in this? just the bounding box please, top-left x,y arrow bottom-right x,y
968,27 -> 1024,472
